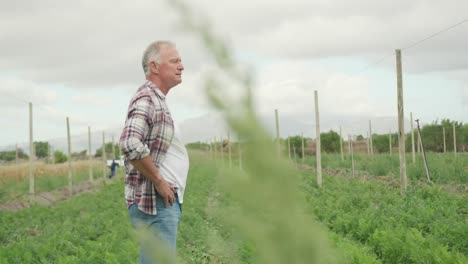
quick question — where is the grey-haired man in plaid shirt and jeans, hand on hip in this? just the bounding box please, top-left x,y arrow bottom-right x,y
120,41 -> 189,263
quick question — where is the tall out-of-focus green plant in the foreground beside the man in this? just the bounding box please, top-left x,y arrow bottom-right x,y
170,1 -> 339,263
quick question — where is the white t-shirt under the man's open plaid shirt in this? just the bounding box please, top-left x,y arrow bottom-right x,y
159,124 -> 189,203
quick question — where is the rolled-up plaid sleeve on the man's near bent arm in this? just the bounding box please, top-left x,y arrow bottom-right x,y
120,96 -> 155,160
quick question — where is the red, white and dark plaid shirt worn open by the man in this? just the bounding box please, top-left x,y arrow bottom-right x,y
120,81 -> 174,215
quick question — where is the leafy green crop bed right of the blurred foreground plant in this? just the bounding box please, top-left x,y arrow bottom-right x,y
303,173 -> 468,263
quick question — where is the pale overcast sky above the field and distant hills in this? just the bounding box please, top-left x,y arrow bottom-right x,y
0,0 -> 468,152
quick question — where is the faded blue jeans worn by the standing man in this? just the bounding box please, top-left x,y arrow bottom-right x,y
128,194 -> 182,264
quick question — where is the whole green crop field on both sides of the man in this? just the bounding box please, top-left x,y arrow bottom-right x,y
0,151 -> 468,263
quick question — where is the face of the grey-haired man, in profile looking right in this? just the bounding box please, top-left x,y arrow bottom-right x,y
157,45 -> 184,88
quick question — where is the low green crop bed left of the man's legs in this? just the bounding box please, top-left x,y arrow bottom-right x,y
0,180 -> 138,263
